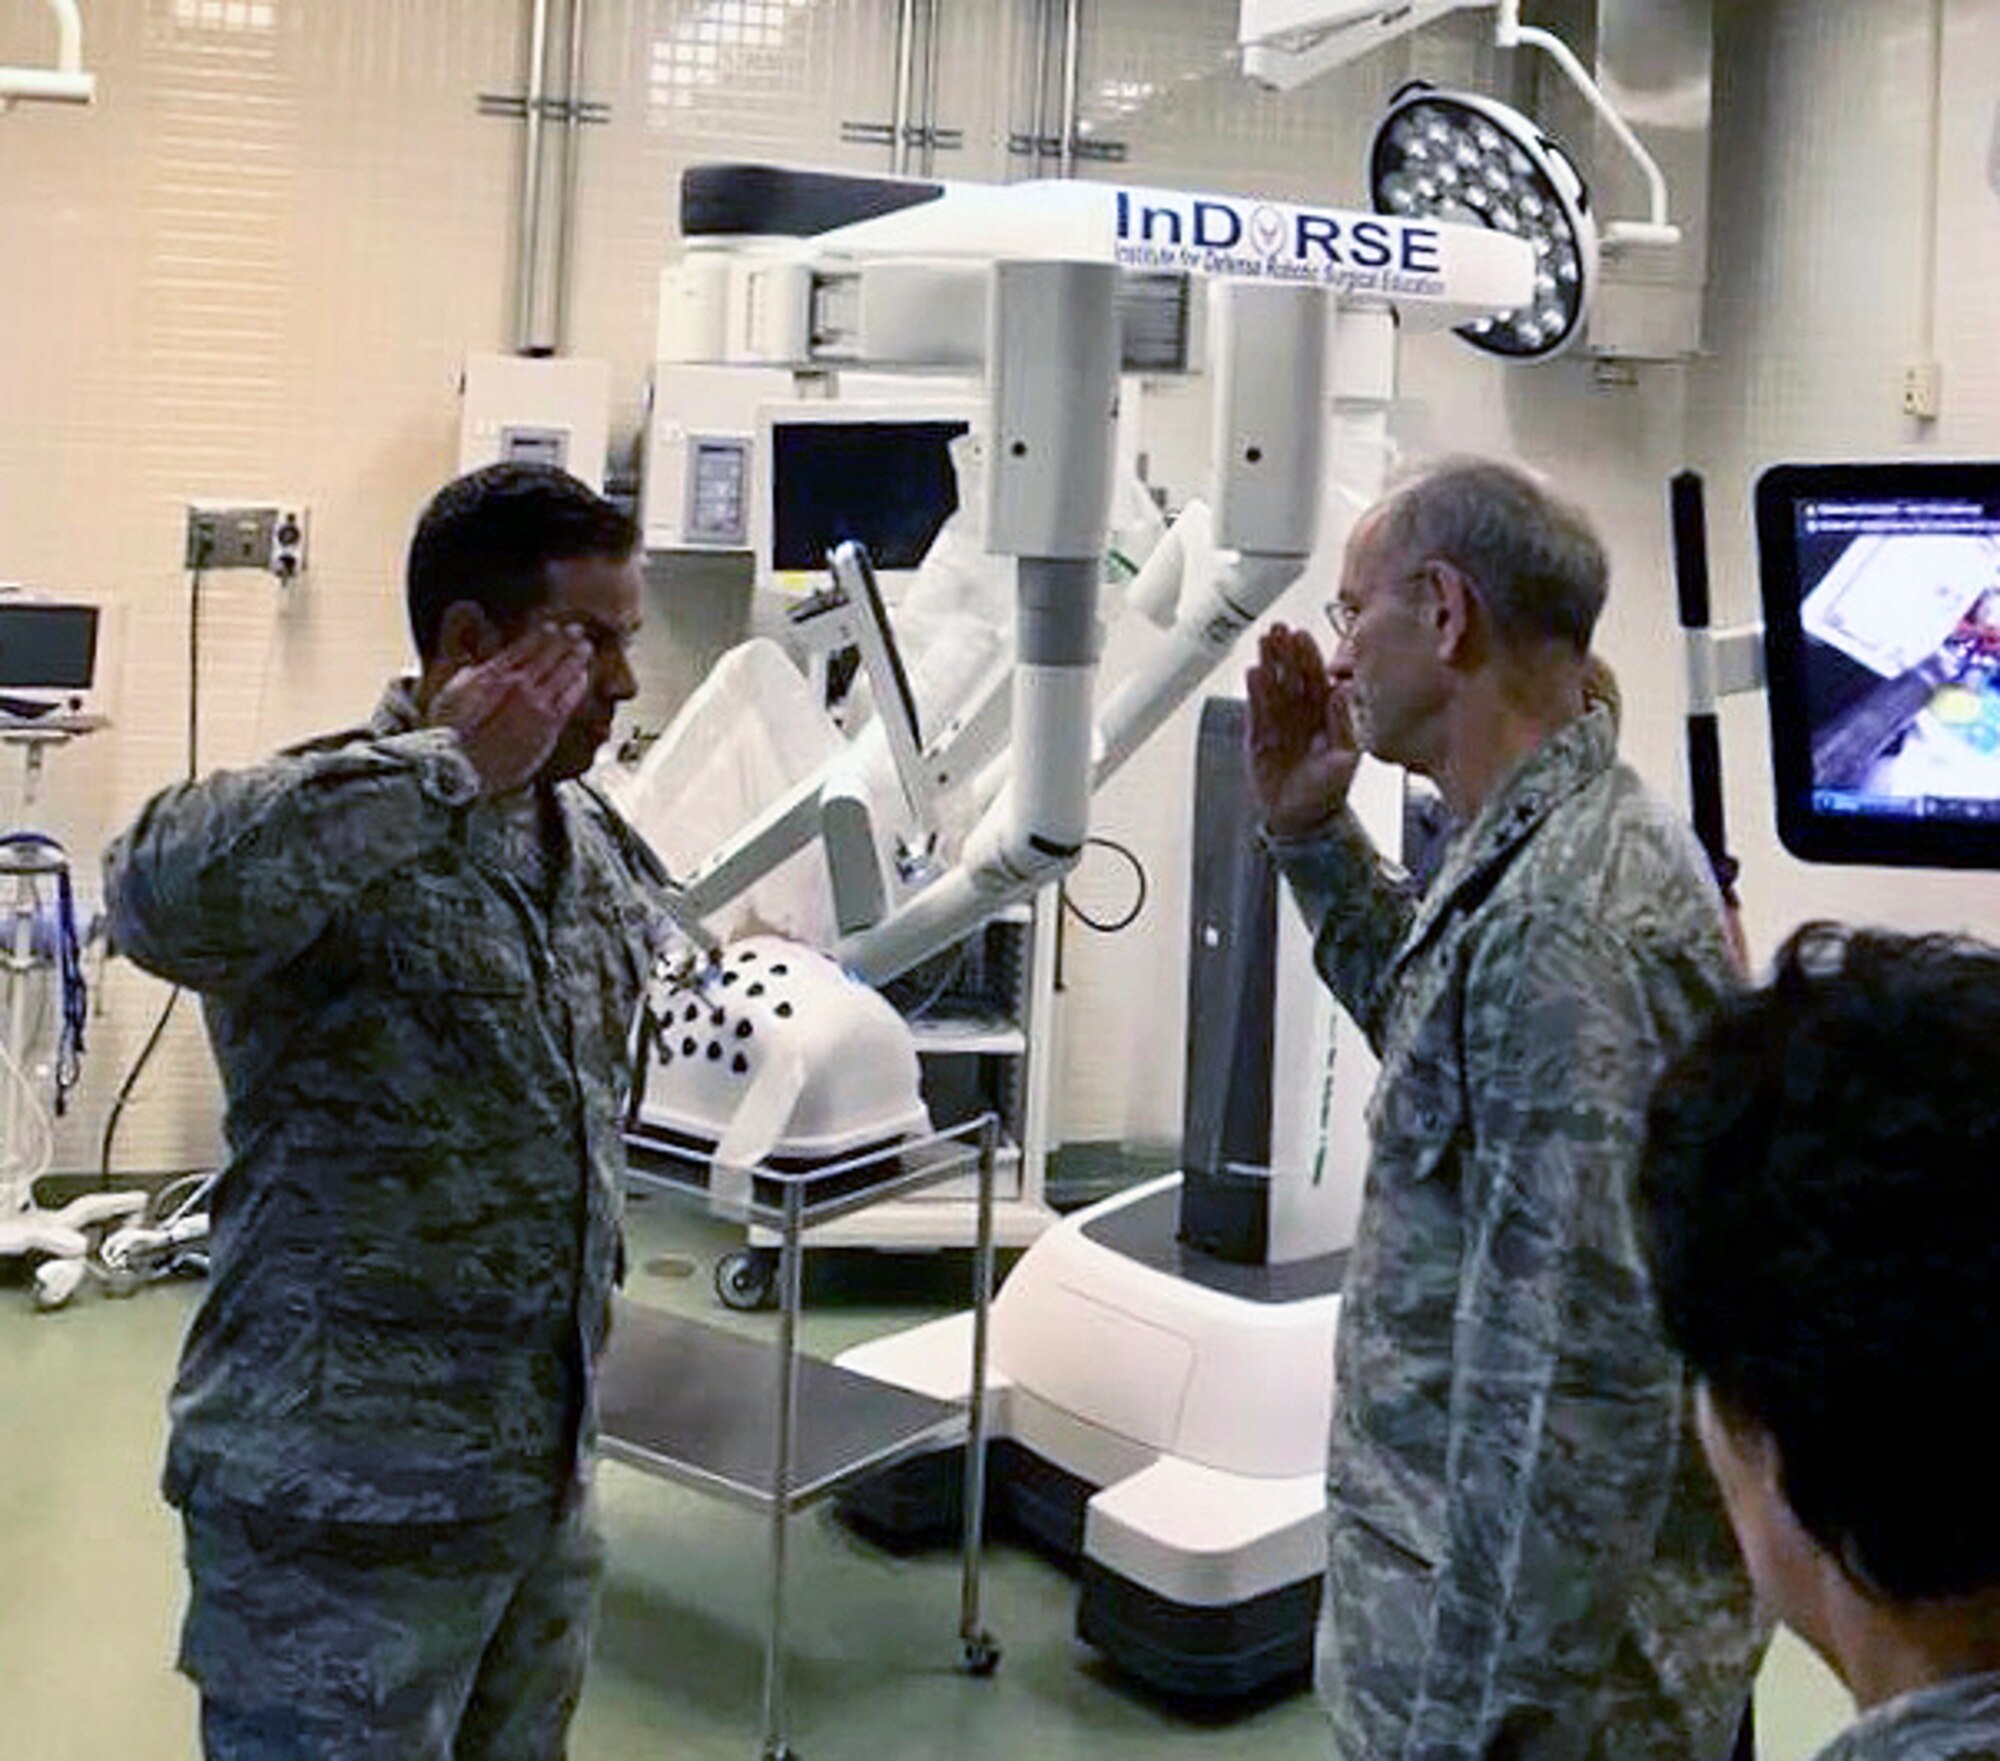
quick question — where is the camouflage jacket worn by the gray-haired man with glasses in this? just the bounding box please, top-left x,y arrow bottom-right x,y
1272,710 -> 1760,1761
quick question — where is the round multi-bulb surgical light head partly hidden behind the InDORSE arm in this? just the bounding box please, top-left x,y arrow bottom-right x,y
1368,80 -> 1598,360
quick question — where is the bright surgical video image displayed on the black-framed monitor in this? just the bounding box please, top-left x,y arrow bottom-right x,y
1798,500 -> 2000,822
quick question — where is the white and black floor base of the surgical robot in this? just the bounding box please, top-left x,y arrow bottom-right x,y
840,1177 -> 1342,1701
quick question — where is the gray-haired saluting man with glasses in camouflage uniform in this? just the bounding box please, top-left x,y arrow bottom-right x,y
1250,460 -> 1758,1761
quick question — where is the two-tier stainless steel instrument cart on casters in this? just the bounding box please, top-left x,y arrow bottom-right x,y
600,1115 -> 1000,1761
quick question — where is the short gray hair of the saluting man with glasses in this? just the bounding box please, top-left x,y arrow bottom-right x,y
1380,458 -> 1610,654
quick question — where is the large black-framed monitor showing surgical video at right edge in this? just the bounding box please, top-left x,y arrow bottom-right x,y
1758,464 -> 2000,866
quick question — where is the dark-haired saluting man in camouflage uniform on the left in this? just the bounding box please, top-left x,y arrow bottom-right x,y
106,464 -> 656,1761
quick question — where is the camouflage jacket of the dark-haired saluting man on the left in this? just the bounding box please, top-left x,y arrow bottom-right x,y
106,684 -> 656,1523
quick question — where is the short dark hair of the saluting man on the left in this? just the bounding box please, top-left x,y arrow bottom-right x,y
404,462 -> 638,660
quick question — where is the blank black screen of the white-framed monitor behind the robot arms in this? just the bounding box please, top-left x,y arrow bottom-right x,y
770,418 -> 970,574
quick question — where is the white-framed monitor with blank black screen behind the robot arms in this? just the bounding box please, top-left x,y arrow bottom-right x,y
750,400 -> 976,604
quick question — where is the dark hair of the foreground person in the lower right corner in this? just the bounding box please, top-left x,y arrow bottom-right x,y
1640,925 -> 2000,1601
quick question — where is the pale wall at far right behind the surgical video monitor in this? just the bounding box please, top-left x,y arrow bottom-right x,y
1688,0 -> 2000,957
